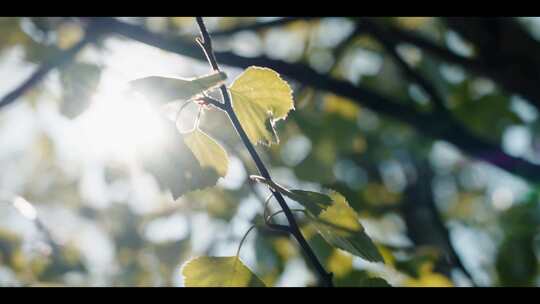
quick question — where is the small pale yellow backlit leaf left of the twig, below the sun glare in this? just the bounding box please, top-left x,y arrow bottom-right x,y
184,128 -> 229,177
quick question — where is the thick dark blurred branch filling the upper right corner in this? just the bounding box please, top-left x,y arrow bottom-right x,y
376,18 -> 540,109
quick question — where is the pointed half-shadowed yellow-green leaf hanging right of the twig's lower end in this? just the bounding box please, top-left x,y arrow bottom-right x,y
308,192 -> 384,262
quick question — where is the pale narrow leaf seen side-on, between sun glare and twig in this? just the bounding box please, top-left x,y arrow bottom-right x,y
130,72 -> 227,103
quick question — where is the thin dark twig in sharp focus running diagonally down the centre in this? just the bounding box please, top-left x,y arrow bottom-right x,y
196,17 -> 333,287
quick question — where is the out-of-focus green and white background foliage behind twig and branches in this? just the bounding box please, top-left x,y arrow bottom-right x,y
0,17 -> 540,287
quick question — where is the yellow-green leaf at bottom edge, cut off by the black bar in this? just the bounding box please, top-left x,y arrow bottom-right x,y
182,256 -> 265,287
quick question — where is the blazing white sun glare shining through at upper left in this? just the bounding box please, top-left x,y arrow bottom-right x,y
73,39 -> 193,163
